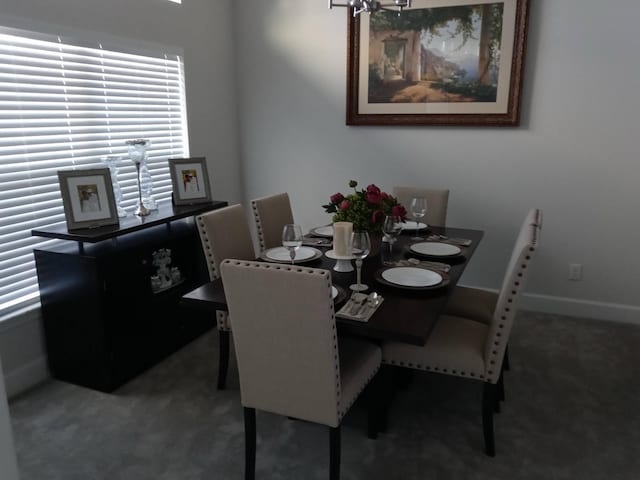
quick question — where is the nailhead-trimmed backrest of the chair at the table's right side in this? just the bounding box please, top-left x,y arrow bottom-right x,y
484,208 -> 542,383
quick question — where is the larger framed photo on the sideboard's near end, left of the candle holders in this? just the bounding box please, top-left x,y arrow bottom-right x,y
58,168 -> 119,230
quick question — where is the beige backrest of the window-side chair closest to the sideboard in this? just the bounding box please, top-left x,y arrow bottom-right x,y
196,204 -> 256,280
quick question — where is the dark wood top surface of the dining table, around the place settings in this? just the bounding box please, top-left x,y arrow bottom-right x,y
182,227 -> 484,345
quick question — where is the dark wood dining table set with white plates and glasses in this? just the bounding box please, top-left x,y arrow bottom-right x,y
181,227 -> 484,345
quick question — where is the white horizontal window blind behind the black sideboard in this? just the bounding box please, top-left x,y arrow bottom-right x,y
0,27 -> 188,318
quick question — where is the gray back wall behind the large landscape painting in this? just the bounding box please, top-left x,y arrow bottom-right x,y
235,0 -> 640,321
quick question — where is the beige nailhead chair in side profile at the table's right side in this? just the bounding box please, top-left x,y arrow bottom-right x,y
382,209 -> 542,456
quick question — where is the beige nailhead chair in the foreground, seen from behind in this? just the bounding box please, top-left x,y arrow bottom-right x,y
221,259 -> 381,479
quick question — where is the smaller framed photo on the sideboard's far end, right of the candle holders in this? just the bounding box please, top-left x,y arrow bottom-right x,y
169,157 -> 211,205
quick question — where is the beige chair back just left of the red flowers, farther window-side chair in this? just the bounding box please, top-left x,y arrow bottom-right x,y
251,193 -> 294,252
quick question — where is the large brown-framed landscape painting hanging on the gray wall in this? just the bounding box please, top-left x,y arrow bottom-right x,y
346,0 -> 528,126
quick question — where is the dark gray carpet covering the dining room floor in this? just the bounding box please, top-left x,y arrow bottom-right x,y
10,312 -> 640,480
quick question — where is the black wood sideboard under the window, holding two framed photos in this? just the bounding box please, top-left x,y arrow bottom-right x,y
31,201 -> 227,392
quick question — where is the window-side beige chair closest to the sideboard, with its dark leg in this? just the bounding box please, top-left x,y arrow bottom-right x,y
196,205 -> 256,390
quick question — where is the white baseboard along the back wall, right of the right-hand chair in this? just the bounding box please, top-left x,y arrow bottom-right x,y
520,294 -> 640,325
